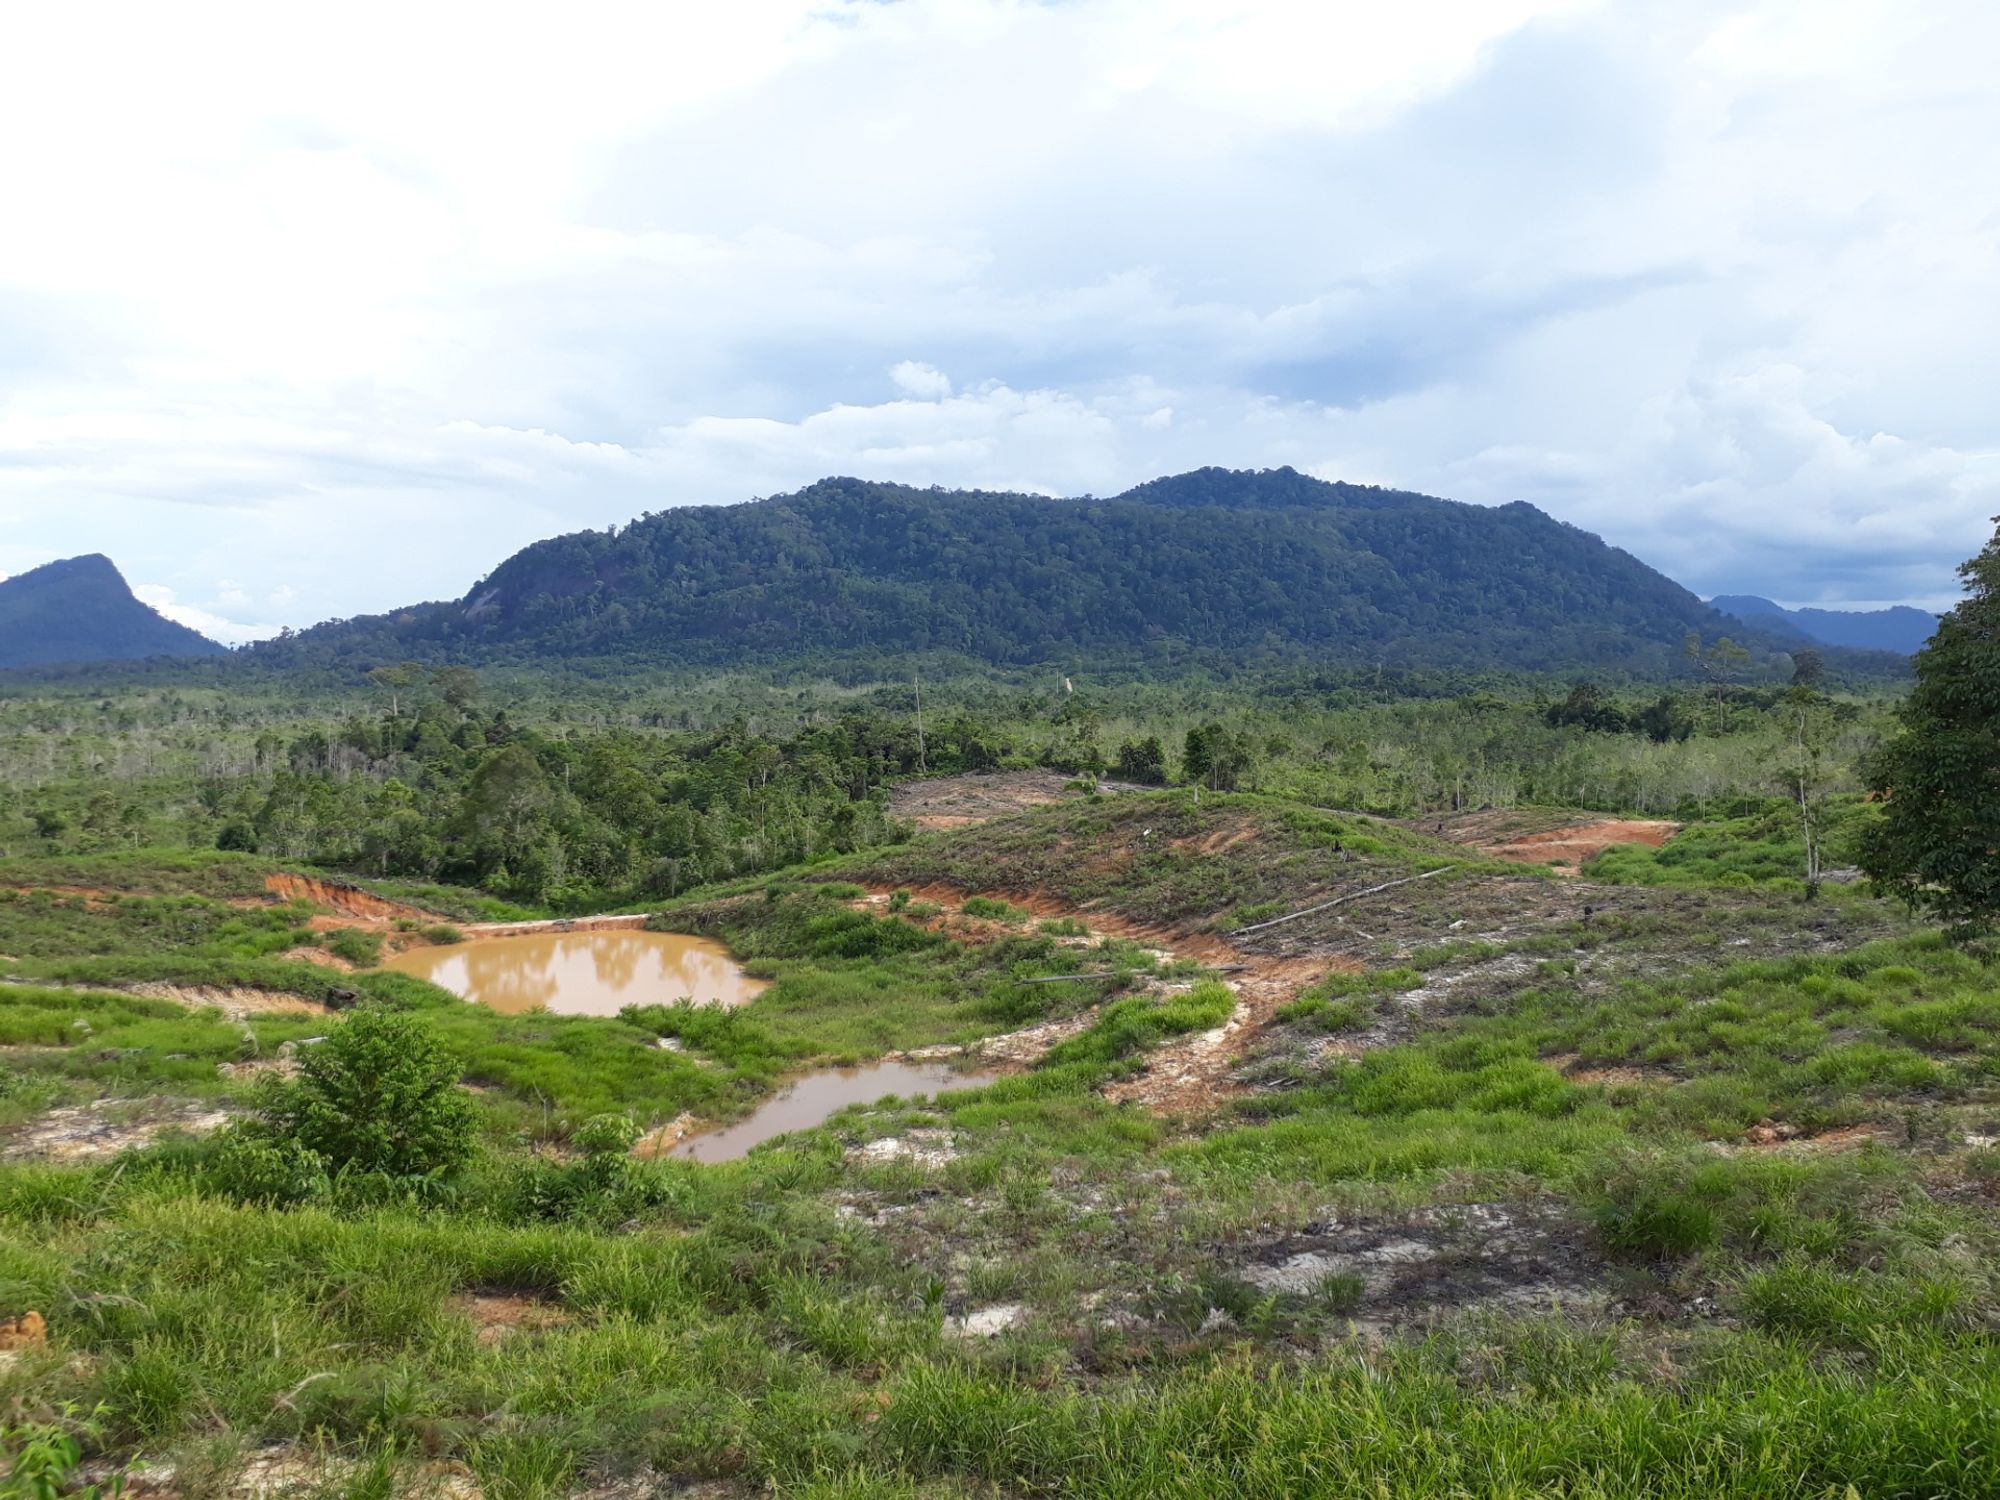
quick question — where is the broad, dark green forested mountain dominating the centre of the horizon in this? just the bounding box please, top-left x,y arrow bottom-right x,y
254,468 -> 1816,670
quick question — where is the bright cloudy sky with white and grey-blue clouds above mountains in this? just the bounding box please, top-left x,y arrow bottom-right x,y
0,0 -> 2000,642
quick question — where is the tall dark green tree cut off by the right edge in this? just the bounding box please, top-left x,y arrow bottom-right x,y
1860,532 -> 2000,924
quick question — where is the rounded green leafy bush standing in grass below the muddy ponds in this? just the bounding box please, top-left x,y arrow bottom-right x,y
264,1008 -> 474,1176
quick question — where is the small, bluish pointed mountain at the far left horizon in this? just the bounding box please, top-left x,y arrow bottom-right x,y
0,552 -> 224,668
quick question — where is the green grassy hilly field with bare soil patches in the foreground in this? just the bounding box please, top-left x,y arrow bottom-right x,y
0,792 -> 2000,1500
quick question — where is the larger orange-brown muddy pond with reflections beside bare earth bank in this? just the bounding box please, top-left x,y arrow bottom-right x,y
382,928 -> 764,1016
